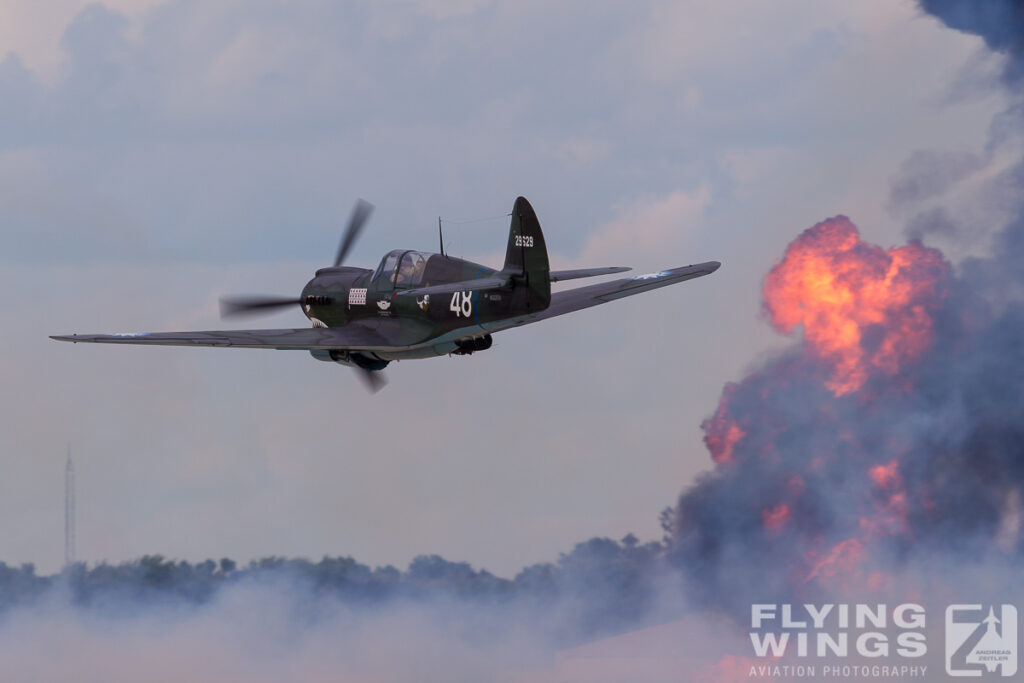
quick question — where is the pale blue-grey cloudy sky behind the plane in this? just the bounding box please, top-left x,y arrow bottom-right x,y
0,0 -> 1005,575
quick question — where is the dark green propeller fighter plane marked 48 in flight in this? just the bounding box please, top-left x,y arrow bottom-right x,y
51,197 -> 721,390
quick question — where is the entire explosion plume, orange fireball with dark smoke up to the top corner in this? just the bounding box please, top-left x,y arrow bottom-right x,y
671,0 -> 1024,610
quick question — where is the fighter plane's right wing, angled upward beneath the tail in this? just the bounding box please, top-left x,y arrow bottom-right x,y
482,261 -> 722,332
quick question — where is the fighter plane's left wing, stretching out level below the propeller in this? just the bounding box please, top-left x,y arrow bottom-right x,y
50,324 -> 393,350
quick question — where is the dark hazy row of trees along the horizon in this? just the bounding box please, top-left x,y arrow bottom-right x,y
0,535 -> 678,640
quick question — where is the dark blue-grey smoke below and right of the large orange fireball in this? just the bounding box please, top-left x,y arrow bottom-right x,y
671,224 -> 1024,613
